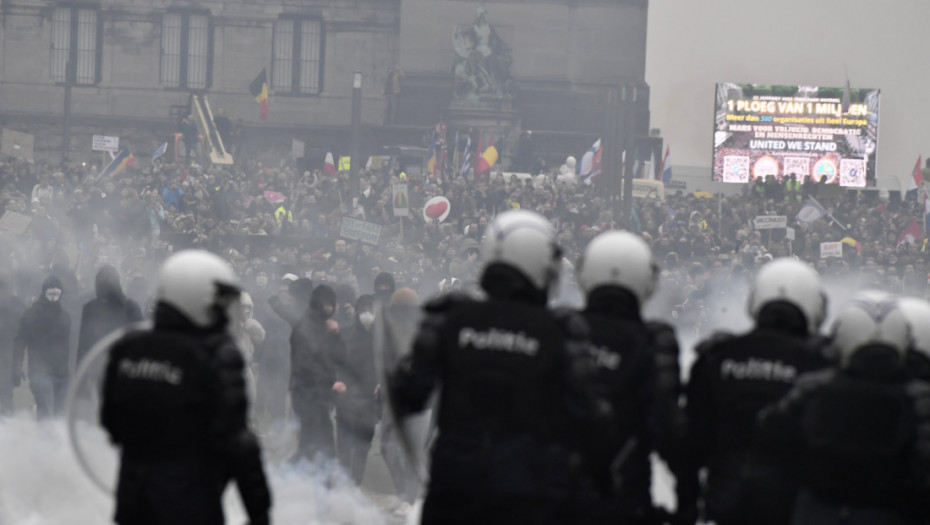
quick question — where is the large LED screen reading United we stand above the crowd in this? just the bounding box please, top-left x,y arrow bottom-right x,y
713,84 -> 879,187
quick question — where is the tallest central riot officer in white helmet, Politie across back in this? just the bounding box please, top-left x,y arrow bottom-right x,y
389,210 -> 604,524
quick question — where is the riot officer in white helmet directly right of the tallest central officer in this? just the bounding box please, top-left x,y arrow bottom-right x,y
577,231 -> 684,524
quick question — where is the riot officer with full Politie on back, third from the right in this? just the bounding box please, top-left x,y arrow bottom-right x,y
678,258 -> 828,525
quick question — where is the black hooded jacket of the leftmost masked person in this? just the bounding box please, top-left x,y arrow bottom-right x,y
13,276 -> 71,376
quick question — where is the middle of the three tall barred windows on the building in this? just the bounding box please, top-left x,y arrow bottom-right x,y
159,12 -> 213,89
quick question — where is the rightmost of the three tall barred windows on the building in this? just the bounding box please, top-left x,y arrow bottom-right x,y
271,16 -> 324,95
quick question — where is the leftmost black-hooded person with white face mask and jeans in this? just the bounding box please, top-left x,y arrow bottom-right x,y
11,275 -> 71,418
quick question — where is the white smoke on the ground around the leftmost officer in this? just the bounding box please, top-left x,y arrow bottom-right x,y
0,412 -> 419,525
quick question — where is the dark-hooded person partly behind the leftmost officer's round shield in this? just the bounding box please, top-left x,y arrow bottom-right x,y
77,264 -> 142,363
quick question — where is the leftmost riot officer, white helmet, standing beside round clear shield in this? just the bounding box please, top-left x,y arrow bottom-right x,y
100,250 -> 271,525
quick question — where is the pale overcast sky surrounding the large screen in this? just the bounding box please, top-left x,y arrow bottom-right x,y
646,0 -> 930,189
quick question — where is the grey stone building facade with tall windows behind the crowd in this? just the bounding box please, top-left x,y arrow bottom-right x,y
0,0 -> 649,167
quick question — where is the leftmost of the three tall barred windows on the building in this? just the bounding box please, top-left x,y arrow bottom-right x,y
51,7 -> 103,86
